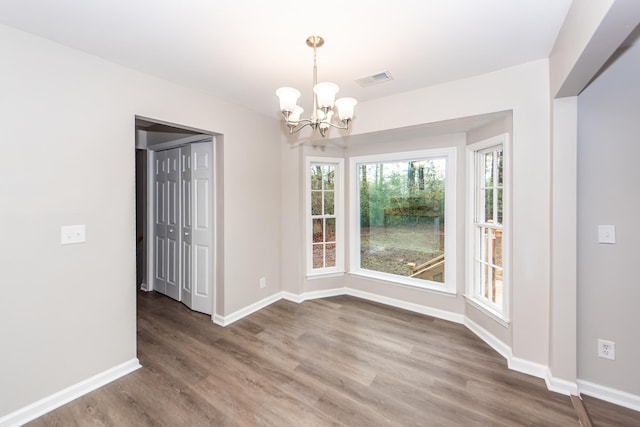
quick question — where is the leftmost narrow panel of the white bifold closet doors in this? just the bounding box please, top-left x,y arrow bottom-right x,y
153,151 -> 168,294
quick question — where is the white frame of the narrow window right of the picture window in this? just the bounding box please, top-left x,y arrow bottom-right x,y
465,133 -> 511,326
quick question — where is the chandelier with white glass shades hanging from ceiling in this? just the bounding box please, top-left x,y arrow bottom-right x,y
276,36 -> 358,137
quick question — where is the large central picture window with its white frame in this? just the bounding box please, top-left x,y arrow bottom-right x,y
350,149 -> 455,293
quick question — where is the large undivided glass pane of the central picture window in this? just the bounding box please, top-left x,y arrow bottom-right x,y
359,158 -> 446,282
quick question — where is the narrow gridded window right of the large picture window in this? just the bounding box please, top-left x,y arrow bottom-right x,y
468,135 -> 507,319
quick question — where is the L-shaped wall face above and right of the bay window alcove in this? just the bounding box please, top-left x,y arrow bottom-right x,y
354,60 -> 550,365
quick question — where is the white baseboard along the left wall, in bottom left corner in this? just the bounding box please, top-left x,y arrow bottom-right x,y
0,358 -> 142,427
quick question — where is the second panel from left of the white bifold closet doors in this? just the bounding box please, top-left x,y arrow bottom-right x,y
166,148 -> 181,301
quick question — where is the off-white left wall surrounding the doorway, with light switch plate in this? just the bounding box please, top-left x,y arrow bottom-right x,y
0,26 -> 281,417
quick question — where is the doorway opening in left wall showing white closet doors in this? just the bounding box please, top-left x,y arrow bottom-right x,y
135,117 -> 217,315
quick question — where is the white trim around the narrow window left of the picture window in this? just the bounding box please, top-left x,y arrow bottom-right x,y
304,156 -> 345,279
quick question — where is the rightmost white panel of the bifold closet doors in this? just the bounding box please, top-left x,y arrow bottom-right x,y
191,142 -> 214,314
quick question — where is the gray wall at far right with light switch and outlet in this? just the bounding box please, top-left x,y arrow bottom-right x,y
578,38 -> 640,395
